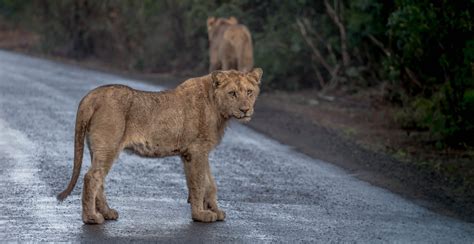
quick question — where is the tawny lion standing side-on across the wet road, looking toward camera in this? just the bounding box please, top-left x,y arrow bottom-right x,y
57,68 -> 263,224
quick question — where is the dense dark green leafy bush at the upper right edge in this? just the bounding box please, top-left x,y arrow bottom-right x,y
387,0 -> 474,145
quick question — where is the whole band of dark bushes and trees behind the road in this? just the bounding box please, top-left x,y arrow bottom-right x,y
0,0 -> 474,147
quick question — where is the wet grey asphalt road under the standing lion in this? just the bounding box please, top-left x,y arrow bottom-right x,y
0,51 -> 474,243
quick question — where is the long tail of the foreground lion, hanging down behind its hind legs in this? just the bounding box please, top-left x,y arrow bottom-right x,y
57,96 -> 95,201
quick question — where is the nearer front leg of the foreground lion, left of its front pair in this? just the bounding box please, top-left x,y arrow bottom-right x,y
184,152 -> 218,222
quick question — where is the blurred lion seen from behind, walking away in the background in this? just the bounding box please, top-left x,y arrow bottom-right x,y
207,17 -> 253,72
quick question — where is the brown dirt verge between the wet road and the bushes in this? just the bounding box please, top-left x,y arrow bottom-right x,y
0,22 -> 474,222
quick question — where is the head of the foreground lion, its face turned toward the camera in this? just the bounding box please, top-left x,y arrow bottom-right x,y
211,68 -> 263,122
